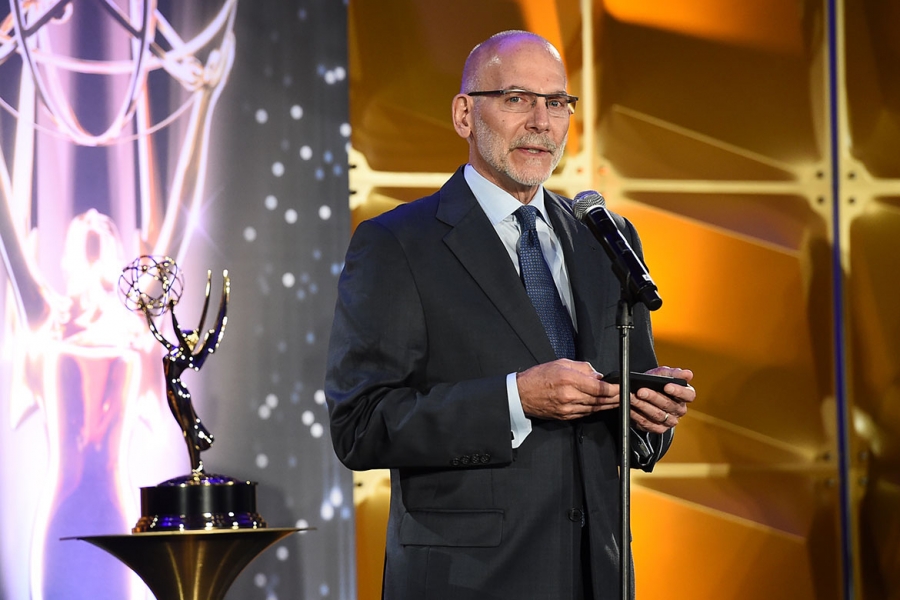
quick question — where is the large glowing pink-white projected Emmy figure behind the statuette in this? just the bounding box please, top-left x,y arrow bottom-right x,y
0,0 -> 237,600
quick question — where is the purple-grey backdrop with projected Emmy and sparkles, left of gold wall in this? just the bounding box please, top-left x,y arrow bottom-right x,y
0,0 -> 355,600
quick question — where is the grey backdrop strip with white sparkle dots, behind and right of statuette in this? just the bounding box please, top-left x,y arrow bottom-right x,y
191,0 -> 356,600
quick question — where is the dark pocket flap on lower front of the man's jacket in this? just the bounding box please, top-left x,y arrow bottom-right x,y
400,510 -> 503,548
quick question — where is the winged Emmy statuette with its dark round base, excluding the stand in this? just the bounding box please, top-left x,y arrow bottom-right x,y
119,256 -> 266,533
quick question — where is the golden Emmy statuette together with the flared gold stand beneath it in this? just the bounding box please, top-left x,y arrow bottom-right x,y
64,256 -> 300,600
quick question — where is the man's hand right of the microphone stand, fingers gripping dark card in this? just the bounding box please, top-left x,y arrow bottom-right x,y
631,367 -> 697,433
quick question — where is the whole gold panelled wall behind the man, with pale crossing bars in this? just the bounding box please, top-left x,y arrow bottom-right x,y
350,0 -> 900,600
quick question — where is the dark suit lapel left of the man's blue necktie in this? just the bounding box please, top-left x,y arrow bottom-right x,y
436,169 -> 556,363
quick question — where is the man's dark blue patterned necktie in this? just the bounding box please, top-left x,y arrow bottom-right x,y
515,206 -> 575,360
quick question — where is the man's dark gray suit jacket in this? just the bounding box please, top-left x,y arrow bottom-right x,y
326,169 -> 671,600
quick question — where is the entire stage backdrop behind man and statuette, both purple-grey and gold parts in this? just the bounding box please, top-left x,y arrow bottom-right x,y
0,0 -> 900,600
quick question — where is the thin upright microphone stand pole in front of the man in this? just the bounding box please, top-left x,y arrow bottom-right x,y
616,294 -> 635,600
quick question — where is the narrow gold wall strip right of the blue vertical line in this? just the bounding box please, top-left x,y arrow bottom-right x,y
837,0 -> 900,600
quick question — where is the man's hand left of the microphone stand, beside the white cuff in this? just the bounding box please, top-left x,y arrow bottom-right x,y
516,358 -> 624,420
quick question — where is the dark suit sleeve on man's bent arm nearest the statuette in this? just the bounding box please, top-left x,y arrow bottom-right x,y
325,221 -> 512,470
